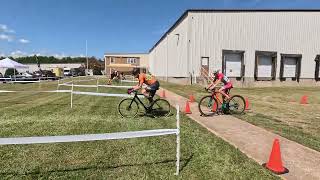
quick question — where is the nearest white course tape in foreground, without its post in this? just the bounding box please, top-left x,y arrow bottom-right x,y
0,129 -> 178,145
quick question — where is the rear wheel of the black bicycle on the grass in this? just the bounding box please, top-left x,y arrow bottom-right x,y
151,99 -> 171,117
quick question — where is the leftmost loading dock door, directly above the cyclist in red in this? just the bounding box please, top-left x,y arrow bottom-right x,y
222,50 -> 244,80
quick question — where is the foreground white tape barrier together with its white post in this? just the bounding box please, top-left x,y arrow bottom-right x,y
0,105 -> 180,175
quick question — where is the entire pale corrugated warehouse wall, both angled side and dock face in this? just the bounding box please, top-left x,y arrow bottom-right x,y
150,12 -> 320,78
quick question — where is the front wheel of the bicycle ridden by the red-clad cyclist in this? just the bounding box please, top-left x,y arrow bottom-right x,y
198,95 -> 218,116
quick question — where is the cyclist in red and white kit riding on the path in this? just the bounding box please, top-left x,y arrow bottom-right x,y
206,70 -> 233,100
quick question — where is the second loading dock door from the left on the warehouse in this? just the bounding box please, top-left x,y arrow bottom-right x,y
254,51 -> 277,81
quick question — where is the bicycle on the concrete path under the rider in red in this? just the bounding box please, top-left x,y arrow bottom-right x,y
198,88 -> 245,116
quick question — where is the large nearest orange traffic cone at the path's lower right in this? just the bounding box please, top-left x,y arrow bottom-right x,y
263,139 -> 289,174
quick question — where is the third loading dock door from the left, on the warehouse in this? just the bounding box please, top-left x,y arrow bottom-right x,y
280,54 -> 302,82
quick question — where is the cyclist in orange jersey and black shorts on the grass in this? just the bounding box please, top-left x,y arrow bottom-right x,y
132,68 -> 160,103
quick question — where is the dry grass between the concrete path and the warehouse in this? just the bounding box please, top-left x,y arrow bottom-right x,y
161,82 -> 320,151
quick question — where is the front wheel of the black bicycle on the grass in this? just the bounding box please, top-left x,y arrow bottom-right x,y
118,98 -> 139,117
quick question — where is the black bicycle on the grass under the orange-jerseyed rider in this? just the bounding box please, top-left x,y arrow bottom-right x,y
118,89 -> 171,117
